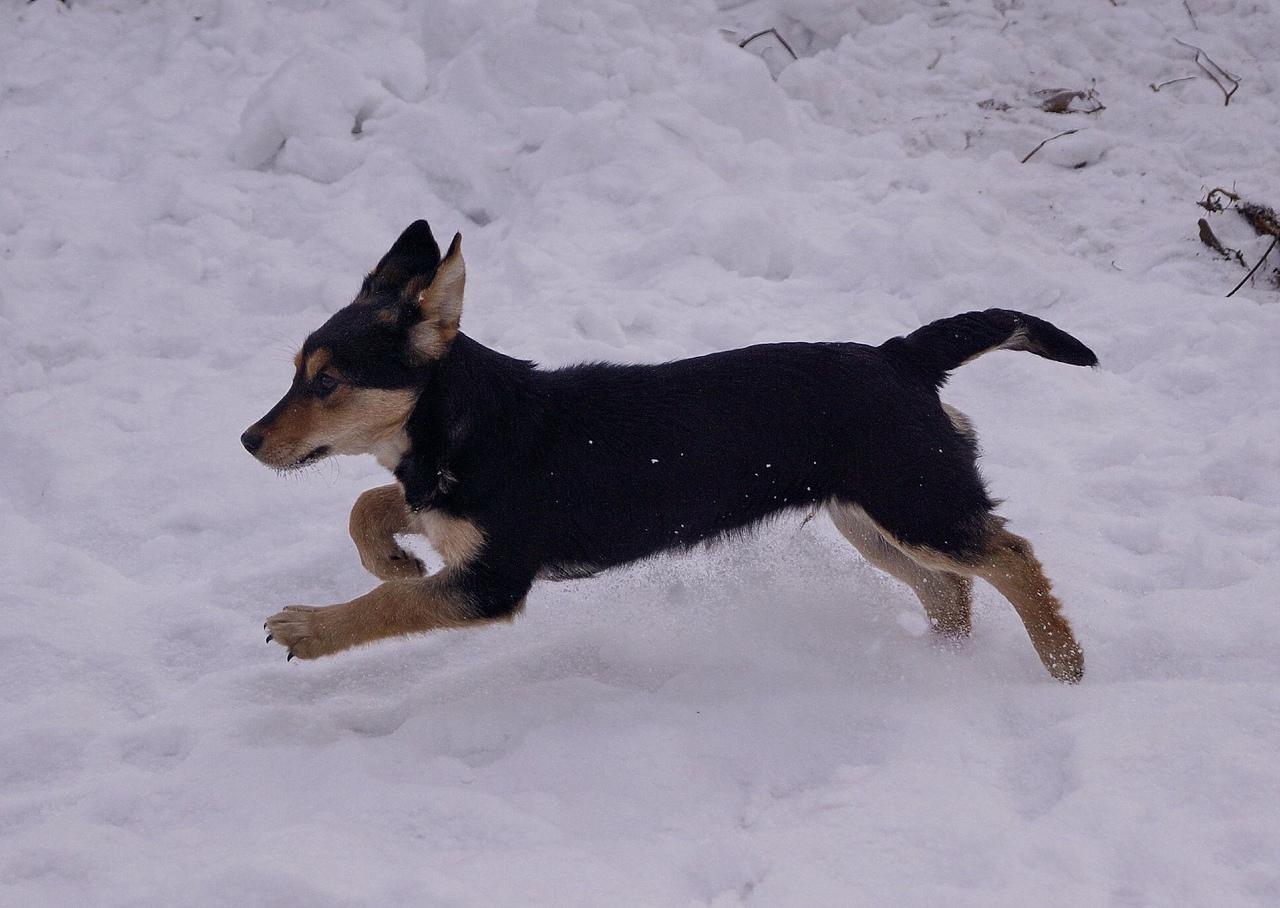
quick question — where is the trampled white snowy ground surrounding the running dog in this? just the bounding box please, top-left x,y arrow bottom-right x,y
0,0 -> 1280,907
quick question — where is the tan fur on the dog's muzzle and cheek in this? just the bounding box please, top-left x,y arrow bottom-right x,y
257,381 -> 419,469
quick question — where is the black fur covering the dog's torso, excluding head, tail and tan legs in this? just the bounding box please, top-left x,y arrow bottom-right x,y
397,317 -> 1090,613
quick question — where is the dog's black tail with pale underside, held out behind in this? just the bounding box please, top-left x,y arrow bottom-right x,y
879,309 -> 1098,388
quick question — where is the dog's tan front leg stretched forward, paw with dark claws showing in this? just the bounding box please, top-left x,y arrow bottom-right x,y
266,570 -> 522,660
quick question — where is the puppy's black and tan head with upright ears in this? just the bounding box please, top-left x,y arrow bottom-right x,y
241,220 -> 466,470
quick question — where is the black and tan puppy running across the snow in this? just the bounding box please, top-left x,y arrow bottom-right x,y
242,220 -> 1097,681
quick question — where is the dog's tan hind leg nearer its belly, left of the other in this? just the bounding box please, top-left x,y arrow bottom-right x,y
827,505 -> 973,638
